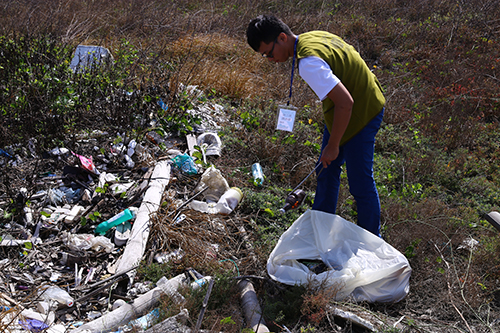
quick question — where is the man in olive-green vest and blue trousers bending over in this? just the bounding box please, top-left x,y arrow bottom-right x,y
247,15 -> 385,236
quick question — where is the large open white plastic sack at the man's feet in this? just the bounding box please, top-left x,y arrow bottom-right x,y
267,210 -> 411,302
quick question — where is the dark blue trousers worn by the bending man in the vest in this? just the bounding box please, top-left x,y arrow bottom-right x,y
312,109 -> 384,237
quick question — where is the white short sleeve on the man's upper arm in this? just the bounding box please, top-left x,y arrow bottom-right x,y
299,56 -> 340,100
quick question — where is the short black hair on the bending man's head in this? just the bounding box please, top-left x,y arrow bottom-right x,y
247,15 -> 292,52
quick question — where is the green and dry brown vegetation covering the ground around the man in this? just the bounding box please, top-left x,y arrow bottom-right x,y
0,0 -> 500,332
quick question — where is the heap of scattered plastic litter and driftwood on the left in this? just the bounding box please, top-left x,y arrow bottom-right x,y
0,89 -> 266,332
